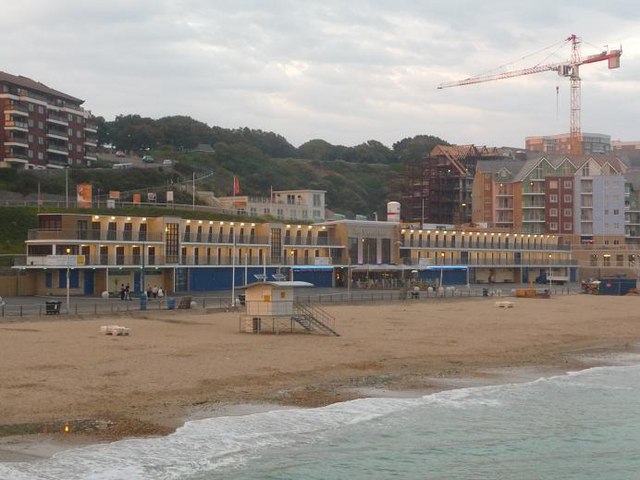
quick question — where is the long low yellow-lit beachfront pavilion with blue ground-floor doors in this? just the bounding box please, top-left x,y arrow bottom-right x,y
10,212 -> 576,295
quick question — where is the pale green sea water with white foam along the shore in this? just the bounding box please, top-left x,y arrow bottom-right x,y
0,358 -> 640,480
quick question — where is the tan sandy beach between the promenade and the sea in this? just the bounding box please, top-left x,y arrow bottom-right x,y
0,295 -> 640,461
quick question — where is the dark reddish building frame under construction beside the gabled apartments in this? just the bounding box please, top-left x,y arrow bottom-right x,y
401,145 -> 500,225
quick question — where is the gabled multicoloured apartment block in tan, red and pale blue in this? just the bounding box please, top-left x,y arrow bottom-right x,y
473,152 -> 628,241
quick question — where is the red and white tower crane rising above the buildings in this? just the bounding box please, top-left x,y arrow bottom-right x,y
438,35 -> 622,155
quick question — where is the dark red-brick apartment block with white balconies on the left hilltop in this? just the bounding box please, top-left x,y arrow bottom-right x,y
0,72 -> 97,168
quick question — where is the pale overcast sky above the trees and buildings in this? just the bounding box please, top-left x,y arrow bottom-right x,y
5,0 -> 640,147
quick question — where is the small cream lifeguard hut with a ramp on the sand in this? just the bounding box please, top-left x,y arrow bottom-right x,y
240,281 -> 338,336
